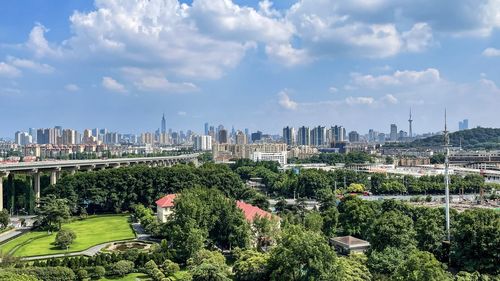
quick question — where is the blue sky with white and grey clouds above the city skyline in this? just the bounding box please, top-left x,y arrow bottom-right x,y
0,0 -> 500,137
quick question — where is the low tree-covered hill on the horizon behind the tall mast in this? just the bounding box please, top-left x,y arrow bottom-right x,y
390,127 -> 500,150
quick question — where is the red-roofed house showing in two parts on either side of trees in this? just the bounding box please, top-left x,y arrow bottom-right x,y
156,194 -> 273,223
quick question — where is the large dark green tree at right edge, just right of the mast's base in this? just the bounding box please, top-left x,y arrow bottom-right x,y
451,209 -> 500,274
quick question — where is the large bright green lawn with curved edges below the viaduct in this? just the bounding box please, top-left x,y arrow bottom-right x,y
0,215 -> 135,257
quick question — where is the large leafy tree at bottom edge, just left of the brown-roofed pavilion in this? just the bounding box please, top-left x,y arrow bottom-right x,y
269,226 -> 336,281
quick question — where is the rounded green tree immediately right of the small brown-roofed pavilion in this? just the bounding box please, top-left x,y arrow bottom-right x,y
368,211 -> 417,250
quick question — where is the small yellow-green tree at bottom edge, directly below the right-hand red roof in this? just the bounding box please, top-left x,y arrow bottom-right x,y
233,250 -> 269,281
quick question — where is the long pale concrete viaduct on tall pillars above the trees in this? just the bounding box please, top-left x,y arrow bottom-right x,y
0,153 -> 199,211
